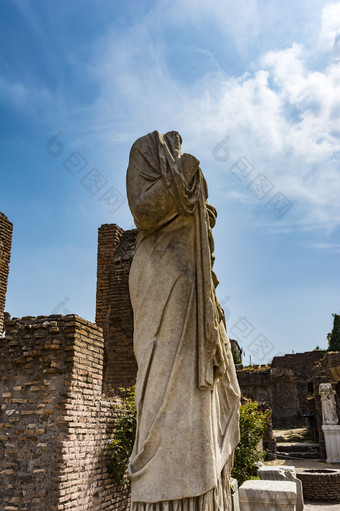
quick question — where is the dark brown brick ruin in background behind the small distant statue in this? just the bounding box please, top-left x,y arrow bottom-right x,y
237,350 -> 340,458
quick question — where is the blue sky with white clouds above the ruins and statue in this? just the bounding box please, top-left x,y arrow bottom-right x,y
0,0 -> 340,363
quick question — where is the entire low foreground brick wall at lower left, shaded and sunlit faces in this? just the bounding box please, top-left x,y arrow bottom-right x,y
0,315 -> 129,511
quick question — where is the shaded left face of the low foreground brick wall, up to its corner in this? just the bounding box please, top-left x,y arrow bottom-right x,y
0,317 -> 64,511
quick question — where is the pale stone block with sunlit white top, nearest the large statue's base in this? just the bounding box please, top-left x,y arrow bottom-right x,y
239,480 -> 296,511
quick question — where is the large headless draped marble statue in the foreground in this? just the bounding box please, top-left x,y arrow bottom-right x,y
127,131 -> 240,511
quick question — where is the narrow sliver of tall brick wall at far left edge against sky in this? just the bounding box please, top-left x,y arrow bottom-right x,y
0,212 -> 13,337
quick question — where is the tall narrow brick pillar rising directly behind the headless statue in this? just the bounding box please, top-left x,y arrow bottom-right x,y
96,224 -> 137,394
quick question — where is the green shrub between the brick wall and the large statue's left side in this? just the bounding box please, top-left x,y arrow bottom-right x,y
107,386 -> 137,485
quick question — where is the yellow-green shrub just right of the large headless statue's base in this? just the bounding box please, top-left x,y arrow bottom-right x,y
231,399 -> 271,485
